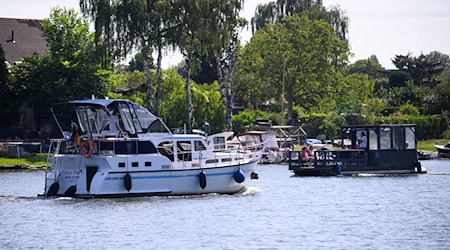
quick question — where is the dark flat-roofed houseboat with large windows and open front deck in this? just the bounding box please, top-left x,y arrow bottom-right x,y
289,124 -> 425,176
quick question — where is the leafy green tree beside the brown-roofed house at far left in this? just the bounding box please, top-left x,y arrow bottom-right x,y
12,8 -> 106,136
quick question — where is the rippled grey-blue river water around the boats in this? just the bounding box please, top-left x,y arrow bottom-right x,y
0,160 -> 450,249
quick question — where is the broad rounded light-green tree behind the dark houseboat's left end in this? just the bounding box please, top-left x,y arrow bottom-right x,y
237,15 -> 349,124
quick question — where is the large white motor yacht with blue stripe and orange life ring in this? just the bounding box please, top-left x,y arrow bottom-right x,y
44,100 -> 263,198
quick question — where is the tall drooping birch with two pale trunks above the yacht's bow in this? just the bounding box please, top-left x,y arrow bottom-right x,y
176,0 -> 242,131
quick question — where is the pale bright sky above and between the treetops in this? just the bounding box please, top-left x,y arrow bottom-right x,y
0,0 -> 450,69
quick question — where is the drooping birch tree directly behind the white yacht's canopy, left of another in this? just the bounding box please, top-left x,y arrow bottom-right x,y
80,0 -> 176,116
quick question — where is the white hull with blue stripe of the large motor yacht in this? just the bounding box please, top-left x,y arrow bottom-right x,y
46,156 -> 257,198
